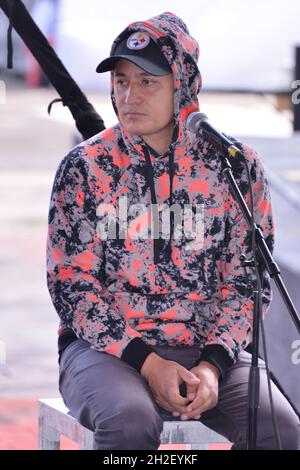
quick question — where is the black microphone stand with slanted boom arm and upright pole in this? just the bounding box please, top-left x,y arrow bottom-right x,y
201,128 -> 300,450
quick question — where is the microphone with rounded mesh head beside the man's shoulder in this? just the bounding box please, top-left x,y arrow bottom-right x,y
186,112 -> 243,157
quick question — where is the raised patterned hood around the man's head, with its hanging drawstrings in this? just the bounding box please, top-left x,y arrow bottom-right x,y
102,12 -> 202,263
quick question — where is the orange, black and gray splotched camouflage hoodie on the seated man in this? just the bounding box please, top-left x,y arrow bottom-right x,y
47,13 -> 273,375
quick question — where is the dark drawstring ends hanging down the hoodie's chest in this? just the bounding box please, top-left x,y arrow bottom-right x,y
143,147 -> 175,264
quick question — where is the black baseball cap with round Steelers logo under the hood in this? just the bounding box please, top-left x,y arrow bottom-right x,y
96,31 -> 172,75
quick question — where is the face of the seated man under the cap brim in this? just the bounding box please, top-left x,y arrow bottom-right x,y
114,59 -> 174,148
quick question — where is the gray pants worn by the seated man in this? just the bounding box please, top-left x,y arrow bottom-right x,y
59,339 -> 299,450
